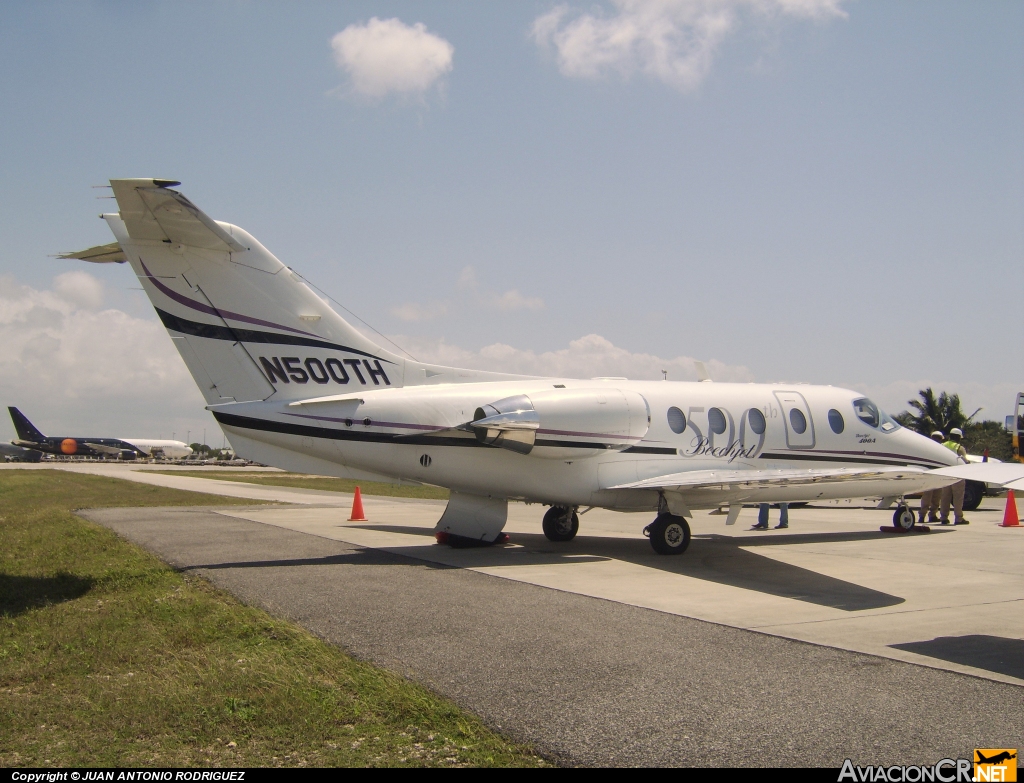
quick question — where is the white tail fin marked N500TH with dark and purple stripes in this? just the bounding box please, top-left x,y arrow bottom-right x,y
102,179 -> 406,405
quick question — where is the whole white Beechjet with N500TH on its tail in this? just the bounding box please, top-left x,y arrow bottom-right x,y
65,179 -> 1024,555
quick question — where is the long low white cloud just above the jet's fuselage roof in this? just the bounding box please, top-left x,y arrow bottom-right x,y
394,327 -> 753,381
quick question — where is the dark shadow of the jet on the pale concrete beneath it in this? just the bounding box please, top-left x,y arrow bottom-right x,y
358,525 -> 904,612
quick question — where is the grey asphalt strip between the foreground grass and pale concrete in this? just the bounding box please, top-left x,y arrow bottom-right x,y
82,497 -> 1024,768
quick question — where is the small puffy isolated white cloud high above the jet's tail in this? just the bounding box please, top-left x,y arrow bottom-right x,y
331,16 -> 455,98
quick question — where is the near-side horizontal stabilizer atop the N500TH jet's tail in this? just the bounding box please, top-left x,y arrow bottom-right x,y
111,179 -> 248,252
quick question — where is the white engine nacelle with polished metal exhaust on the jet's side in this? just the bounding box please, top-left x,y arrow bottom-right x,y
469,388 -> 650,460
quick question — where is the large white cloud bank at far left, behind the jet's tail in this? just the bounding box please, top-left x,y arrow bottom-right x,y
0,270 -> 210,445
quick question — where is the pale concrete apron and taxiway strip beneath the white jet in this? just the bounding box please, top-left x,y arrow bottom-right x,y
47,464 -> 1024,685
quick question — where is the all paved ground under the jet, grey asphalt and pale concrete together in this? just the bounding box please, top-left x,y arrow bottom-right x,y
9,464 -> 1024,766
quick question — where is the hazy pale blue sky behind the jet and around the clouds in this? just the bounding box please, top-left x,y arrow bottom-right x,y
0,0 -> 1024,440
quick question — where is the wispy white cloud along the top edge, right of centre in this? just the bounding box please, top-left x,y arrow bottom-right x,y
531,0 -> 846,90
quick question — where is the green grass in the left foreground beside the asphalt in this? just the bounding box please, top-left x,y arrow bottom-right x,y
0,471 -> 544,767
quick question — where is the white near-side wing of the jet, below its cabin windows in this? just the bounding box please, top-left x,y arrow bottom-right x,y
607,467 -> 937,492
